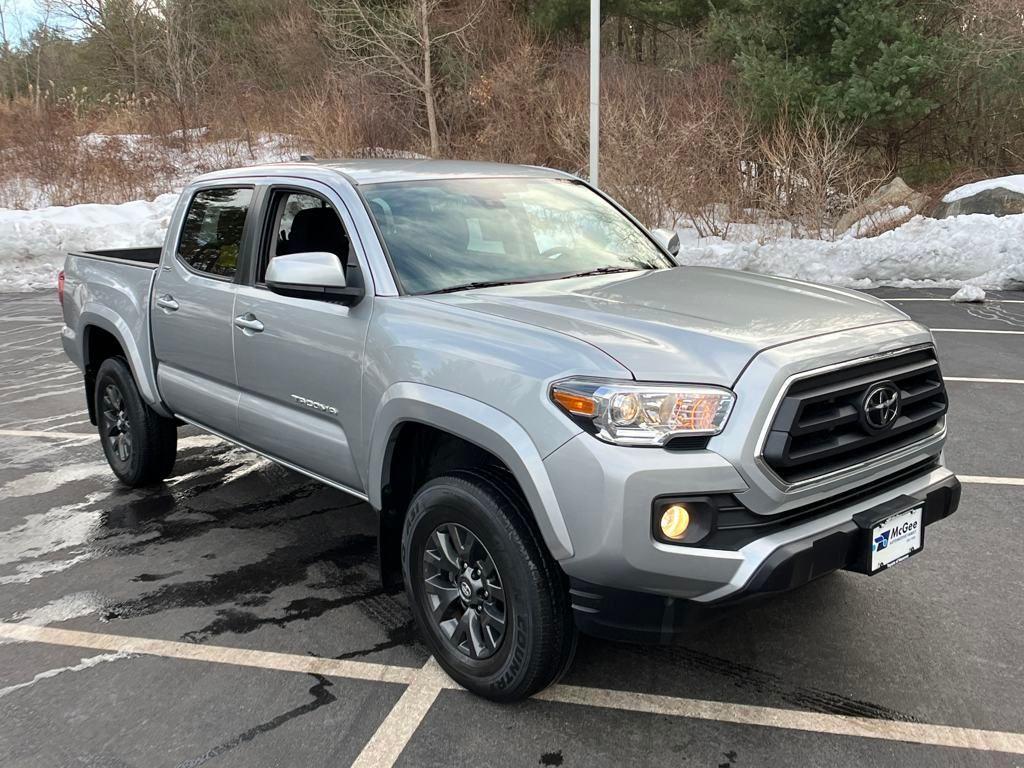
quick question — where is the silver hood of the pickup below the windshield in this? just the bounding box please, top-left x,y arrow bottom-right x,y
429,267 -> 906,386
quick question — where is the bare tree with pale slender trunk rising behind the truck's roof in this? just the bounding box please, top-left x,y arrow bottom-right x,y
318,0 -> 475,157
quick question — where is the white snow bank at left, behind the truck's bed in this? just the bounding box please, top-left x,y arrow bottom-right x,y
0,194 -> 178,291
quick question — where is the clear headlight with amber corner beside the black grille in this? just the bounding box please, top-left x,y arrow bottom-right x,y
551,379 -> 736,445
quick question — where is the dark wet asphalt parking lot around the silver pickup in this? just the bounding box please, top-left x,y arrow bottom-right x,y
0,289 -> 1024,768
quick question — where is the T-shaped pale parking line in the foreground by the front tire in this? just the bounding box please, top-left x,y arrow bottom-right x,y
0,623 -> 1024,768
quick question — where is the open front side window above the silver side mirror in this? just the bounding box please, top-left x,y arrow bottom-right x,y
256,190 -> 349,283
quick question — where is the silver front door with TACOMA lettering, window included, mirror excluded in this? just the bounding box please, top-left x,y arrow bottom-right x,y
232,179 -> 373,492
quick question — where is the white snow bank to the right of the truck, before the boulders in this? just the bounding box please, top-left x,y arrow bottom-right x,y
680,215 -> 1024,289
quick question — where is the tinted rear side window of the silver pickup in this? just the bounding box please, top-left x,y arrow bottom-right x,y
178,187 -> 253,280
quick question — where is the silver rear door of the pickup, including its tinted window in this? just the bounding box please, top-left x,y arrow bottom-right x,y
151,183 -> 255,435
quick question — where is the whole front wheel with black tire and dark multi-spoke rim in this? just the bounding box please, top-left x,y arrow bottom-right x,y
401,469 -> 577,701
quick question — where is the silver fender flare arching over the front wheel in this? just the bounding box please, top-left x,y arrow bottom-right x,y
368,382 -> 572,560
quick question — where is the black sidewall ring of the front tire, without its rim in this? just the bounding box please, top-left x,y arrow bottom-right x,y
402,478 -> 539,697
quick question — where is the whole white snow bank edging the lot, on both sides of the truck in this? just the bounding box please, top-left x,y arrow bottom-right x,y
0,167 -> 1024,291
